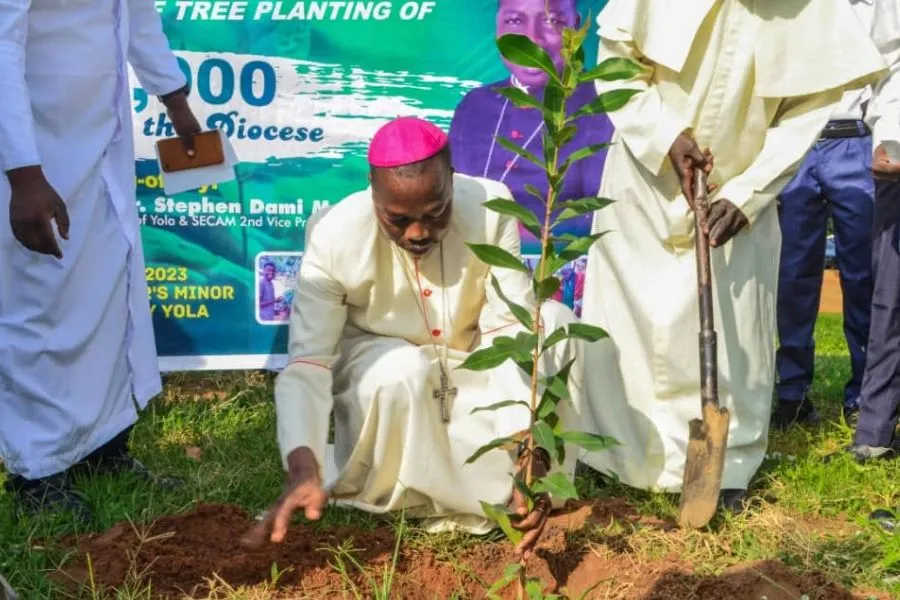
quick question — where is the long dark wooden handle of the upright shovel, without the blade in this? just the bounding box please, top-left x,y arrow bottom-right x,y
694,169 -> 719,407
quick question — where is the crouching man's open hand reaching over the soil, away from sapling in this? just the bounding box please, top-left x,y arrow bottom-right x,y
241,448 -> 328,548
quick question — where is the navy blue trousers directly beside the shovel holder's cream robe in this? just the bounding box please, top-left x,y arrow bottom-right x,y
776,135 -> 875,407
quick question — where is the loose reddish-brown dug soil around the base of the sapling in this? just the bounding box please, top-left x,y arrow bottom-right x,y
54,501 -> 861,600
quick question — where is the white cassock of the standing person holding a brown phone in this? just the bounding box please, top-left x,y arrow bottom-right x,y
0,0 -> 185,478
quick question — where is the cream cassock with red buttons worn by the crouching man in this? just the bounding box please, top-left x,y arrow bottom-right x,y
275,175 -> 582,532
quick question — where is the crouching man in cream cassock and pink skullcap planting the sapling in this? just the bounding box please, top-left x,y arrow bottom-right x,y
247,118 -> 582,554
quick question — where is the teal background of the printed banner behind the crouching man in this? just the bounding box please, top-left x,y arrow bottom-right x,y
134,0 -> 606,368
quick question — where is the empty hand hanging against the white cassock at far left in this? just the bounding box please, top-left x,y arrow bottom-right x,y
6,167 -> 69,259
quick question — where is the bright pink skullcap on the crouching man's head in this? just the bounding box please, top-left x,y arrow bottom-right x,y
369,117 -> 447,168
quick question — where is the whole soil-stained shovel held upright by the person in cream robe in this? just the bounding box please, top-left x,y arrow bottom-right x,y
678,169 -> 730,528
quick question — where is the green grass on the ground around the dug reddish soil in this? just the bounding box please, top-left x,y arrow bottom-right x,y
0,316 -> 900,600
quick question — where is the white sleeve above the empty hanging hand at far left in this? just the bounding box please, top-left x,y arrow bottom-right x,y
0,0 -> 41,171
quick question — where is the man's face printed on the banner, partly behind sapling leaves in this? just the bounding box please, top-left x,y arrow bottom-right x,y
497,0 -> 580,88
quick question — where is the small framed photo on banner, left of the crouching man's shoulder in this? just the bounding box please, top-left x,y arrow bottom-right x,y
255,252 -> 303,325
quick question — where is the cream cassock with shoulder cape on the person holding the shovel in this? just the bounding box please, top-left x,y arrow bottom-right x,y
582,0 -> 884,492
